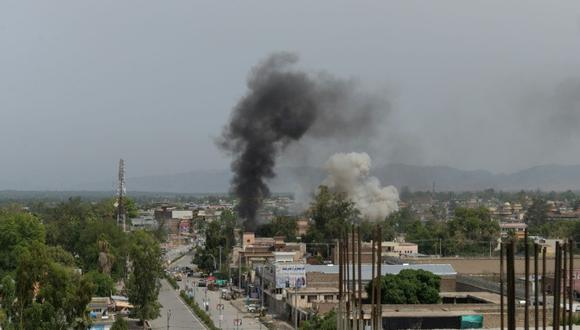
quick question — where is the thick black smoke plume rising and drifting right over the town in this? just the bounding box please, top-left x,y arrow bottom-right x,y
218,53 -> 386,230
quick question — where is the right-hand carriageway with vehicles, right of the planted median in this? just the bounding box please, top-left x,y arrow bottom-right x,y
175,256 -> 266,330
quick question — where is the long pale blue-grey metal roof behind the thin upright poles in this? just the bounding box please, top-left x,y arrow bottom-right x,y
306,264 -> 457,281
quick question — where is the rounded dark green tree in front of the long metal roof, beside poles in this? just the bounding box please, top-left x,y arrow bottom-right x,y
366,269 -> 441,304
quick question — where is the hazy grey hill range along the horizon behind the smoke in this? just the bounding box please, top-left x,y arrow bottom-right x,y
71,164 -> 580,193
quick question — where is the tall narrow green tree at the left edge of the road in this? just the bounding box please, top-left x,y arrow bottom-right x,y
127,231 -> 163,324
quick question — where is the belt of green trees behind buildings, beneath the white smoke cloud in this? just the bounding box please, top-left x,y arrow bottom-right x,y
304,186 -> 500,255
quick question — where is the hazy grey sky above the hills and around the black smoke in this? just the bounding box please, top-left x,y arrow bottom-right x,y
0,0 -> 580,189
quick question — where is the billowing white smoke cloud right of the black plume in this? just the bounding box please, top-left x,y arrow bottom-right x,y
322,152 -> 399,220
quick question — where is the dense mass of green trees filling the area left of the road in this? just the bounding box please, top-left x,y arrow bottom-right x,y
0,198 -> 161,329
